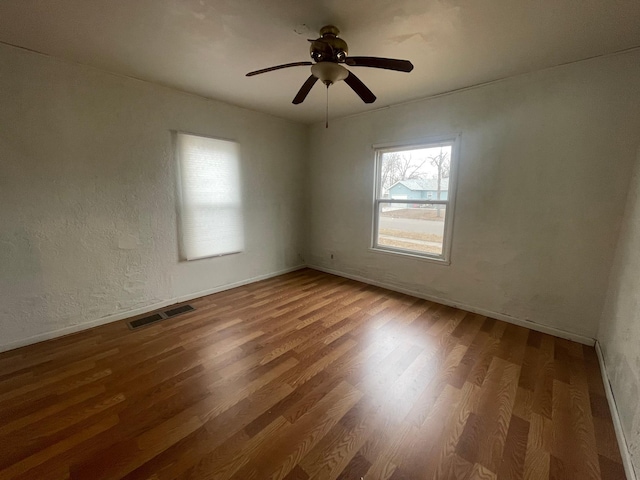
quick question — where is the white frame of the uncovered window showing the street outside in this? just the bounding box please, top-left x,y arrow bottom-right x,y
369,133 -> 461,265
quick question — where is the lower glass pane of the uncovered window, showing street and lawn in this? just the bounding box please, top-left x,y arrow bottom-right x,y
377,200 -> 447,255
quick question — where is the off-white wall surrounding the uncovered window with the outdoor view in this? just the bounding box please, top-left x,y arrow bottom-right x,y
307,51 -> 640,338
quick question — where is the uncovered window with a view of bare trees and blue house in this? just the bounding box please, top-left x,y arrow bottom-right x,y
372,138 -> 457,262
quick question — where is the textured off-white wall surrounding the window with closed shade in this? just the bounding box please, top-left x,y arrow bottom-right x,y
0,45 -> 308,350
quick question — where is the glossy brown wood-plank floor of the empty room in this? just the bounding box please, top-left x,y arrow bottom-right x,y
0,270 -> 624,480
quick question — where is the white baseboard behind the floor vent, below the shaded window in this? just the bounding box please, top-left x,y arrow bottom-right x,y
0,265 -> 306,353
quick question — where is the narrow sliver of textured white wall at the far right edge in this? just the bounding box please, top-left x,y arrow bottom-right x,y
598,145 -> 640,473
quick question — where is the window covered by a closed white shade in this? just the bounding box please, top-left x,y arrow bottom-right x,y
177,133 -> 244,260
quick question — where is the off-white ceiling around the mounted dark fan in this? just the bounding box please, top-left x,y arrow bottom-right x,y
0,0 -> 640,122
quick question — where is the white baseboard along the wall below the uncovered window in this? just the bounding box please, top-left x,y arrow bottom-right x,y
308,265 -> 595,347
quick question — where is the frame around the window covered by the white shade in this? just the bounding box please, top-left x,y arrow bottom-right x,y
171,130 -> 246,262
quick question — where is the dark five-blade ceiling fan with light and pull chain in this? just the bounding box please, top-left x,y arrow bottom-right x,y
247,25 -> 413,105
